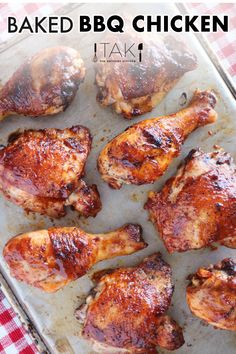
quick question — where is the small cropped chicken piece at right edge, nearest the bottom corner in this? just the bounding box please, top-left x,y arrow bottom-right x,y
187,258 -> 236,331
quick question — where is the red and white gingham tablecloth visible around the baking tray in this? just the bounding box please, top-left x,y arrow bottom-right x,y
0,2 -> 236,354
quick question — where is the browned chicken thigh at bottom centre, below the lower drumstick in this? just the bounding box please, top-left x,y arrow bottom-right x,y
76,253 -> 184,354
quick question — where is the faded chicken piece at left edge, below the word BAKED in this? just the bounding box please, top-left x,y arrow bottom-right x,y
0,47 -> 85,120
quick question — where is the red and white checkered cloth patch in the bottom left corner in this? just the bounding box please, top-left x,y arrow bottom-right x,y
0,291 -> 39,354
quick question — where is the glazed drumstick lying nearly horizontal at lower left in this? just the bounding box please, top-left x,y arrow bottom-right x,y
3,224 -> 147,292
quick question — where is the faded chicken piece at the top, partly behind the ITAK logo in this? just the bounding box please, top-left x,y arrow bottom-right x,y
96,35 -> 197,119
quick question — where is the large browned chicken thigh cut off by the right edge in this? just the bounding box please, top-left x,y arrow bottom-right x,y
145,149 -> 236,253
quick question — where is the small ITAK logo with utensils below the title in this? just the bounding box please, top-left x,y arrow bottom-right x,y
93,42 -> 143,63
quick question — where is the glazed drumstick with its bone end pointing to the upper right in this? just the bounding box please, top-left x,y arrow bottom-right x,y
98,90 -> 217,189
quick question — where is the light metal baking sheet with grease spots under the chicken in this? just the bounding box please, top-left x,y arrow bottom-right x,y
0,4 -> 236,354
